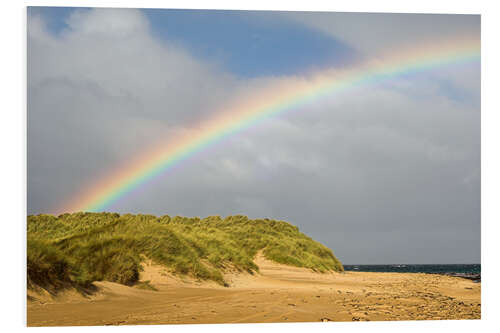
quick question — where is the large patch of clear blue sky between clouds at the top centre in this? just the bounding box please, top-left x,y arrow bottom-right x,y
144,9 -> 355,77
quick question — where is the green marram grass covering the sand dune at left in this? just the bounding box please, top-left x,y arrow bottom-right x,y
27,213 -> 343,288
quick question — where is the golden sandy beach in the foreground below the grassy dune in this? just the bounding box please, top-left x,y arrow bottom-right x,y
27,255 -> 481,326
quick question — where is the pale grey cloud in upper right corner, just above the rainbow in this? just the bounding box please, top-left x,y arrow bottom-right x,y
287,12 -> 481,55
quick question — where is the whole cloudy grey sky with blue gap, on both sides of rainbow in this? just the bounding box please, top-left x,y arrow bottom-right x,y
27,7 -> 481,264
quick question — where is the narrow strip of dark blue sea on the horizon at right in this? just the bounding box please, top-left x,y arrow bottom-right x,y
344,264 -> 481,275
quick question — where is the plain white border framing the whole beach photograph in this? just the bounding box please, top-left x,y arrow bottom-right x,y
0,0 -> 500,333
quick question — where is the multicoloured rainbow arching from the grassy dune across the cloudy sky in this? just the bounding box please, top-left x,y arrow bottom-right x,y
58,37 -> 480,212
